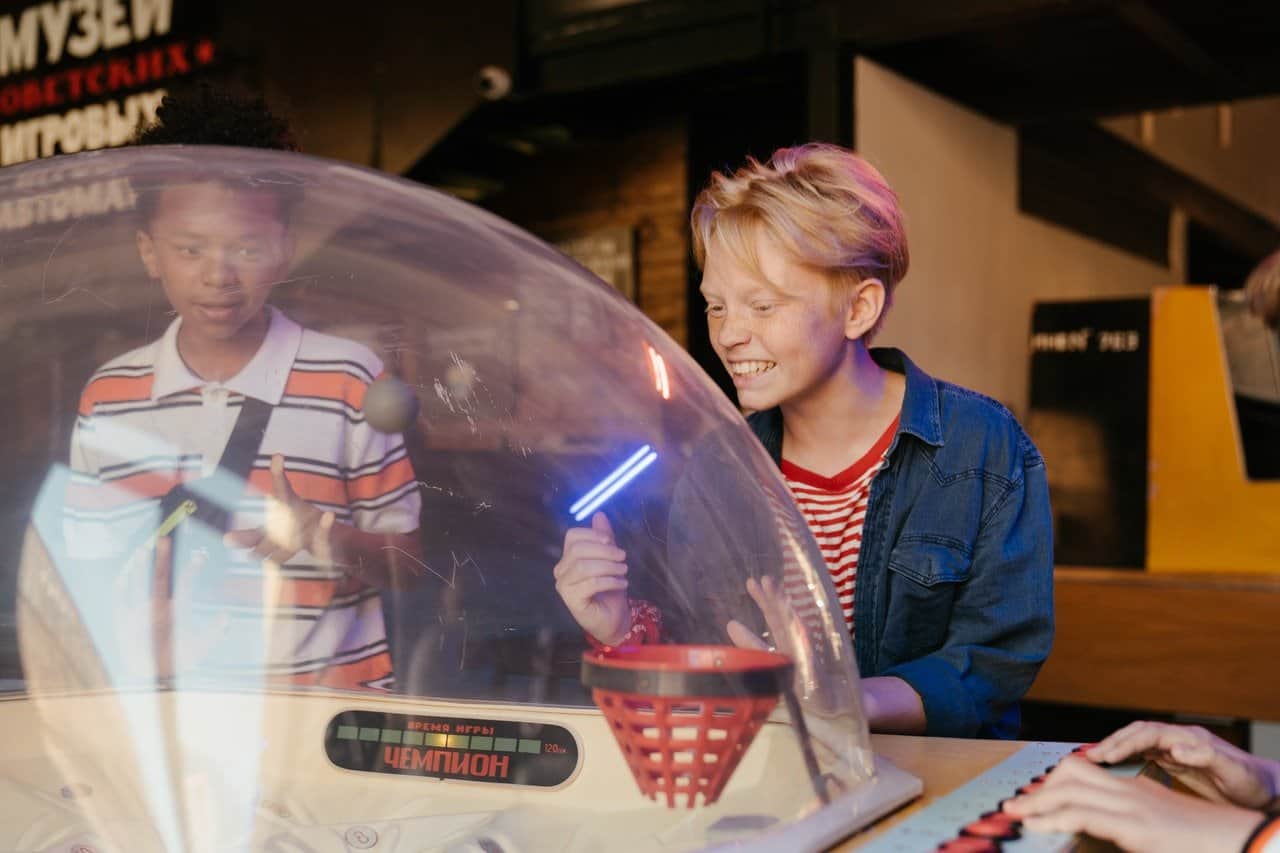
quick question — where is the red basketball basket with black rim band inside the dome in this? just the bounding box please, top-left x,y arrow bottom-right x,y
582,646 -> 792,808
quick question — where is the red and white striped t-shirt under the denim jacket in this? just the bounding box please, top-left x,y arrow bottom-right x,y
782,418 -> 899,634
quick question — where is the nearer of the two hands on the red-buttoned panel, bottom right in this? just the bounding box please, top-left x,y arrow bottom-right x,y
1004,757 -> 1261,853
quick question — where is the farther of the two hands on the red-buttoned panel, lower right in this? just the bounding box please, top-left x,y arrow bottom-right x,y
1085,721 -> 1280,808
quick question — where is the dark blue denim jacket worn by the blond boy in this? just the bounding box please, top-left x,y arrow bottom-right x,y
748,348 -> 1053,738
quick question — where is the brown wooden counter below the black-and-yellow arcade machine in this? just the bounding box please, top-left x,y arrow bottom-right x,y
1027,563 -> 1280,721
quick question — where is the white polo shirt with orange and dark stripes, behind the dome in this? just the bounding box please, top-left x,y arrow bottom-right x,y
64,306 -> 420,688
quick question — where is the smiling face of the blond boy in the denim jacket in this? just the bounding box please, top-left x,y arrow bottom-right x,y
701,232 -> 850,411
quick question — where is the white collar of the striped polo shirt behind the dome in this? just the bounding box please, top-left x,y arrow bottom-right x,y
151,305 -> 302,406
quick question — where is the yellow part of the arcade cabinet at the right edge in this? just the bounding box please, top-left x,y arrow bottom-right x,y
1147,287 -> 1280,574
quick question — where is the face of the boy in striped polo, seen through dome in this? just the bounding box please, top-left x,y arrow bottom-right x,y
137,181 -> 293,345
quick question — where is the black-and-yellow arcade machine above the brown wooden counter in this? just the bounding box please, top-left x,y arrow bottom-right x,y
1028,286 -> 1280,574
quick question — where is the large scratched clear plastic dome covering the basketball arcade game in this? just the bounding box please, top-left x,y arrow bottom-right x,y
0,147 -> 921,852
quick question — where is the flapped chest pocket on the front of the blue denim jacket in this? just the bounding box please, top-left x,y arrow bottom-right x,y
878,534 -> 973,670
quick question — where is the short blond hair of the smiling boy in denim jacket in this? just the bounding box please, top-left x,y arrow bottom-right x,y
690,142 -> 909,325
